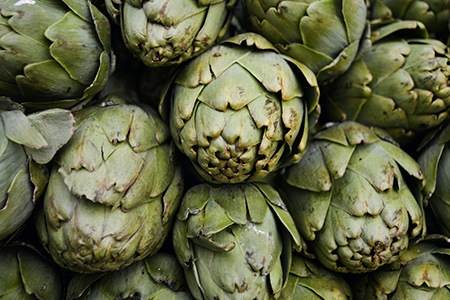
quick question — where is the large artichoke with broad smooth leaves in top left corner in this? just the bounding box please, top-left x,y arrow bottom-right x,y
0,0 -> 113,110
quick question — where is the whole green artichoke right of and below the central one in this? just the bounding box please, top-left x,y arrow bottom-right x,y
283,122 -> 425,273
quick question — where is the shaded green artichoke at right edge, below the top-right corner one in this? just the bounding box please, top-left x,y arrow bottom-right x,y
321,21 -> 450,145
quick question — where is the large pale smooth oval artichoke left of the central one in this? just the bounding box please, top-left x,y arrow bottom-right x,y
37,95 -> 184,273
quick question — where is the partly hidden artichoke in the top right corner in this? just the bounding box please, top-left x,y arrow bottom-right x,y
369,0 -> 450,43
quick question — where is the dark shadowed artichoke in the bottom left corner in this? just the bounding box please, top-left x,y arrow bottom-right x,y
0,244 -> 64,300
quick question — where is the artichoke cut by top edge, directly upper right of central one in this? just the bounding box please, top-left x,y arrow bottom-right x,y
244,0 -> 367,83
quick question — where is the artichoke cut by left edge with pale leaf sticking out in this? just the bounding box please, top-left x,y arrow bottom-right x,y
0,97 -> 74,240
